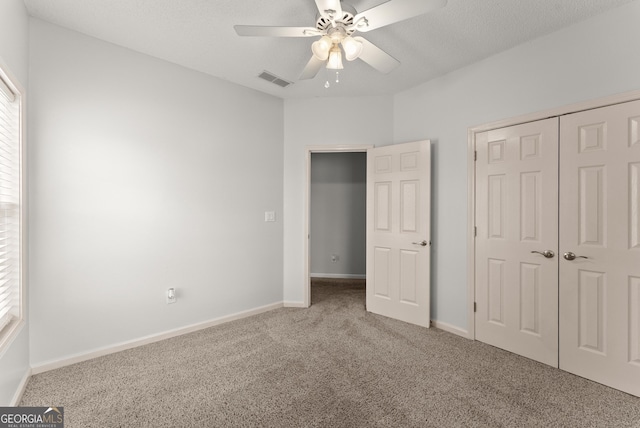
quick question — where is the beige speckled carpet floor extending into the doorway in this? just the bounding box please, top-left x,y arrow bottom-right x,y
21,281 -> 640,428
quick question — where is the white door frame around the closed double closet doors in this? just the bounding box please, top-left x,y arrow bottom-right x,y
467,90 -> 640,339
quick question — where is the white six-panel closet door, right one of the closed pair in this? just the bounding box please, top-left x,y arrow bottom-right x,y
560,101 -> 640,396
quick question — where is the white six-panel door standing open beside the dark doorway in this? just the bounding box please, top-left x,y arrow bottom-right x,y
367,141 -> 431,327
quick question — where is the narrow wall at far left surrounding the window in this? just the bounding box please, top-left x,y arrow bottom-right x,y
0,0 -> 29,406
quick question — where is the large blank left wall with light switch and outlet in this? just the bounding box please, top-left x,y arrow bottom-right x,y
29,20 -> 284,367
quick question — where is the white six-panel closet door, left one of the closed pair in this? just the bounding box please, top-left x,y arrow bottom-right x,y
475,118 -> 558,367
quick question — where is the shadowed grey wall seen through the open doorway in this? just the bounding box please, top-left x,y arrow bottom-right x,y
309,153 -> 367,278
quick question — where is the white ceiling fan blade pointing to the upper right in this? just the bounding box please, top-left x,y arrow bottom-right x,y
353,0 -> 447,32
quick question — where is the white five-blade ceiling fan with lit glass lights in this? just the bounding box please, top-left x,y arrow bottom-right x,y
234,0 -> 447,80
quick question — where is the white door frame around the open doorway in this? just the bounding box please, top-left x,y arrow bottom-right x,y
303,144 -> 374,308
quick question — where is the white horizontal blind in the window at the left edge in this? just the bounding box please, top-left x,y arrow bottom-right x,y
0,76 -> 21,337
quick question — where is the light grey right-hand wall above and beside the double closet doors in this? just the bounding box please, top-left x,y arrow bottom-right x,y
394,1 -> 640,329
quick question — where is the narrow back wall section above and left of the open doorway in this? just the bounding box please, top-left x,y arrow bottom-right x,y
284,96 -> 393,303
